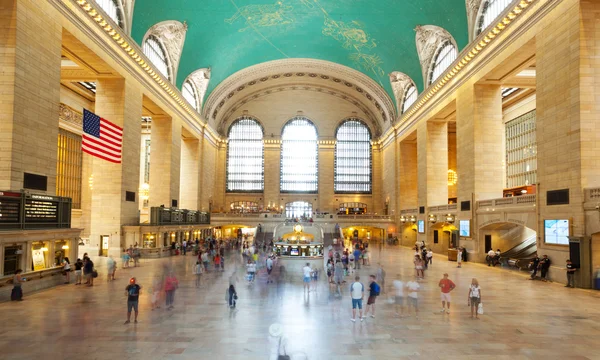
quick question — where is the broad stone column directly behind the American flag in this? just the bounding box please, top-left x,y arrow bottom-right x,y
82,79 -> 142,257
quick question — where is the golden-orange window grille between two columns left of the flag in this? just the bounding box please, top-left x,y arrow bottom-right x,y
56,129 -> 82,209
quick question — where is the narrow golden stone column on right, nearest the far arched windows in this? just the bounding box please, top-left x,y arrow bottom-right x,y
398,140 -> 419,210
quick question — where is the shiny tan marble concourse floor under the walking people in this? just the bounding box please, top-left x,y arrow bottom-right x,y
0,247 -> 600,360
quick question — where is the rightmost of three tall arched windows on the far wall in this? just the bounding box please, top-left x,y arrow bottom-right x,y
334,119 -> 371,194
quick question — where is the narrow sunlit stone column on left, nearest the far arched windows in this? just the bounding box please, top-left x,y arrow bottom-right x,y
179,138 -> 201,210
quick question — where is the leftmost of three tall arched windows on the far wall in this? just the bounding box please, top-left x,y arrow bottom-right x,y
227,117 -> 265,192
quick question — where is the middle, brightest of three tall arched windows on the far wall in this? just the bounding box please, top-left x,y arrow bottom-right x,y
280,116 -> 319,193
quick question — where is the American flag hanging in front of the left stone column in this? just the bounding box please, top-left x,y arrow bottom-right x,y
81,109 -> 123,164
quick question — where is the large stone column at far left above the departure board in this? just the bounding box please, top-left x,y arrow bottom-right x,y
0,0 -> 62,191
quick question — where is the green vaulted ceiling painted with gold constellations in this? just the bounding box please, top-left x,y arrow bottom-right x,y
132,0 -> 468,105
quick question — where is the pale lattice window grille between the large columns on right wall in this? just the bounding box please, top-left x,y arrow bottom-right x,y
505,110 -> 537,188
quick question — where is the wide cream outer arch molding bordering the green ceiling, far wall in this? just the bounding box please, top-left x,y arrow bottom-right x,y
203,59 -> 396,134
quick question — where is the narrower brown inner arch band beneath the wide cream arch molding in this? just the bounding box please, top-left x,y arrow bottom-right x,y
217,84 -> 382,138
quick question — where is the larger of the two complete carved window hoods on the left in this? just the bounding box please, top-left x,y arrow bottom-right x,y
142,20 -> 187,83
